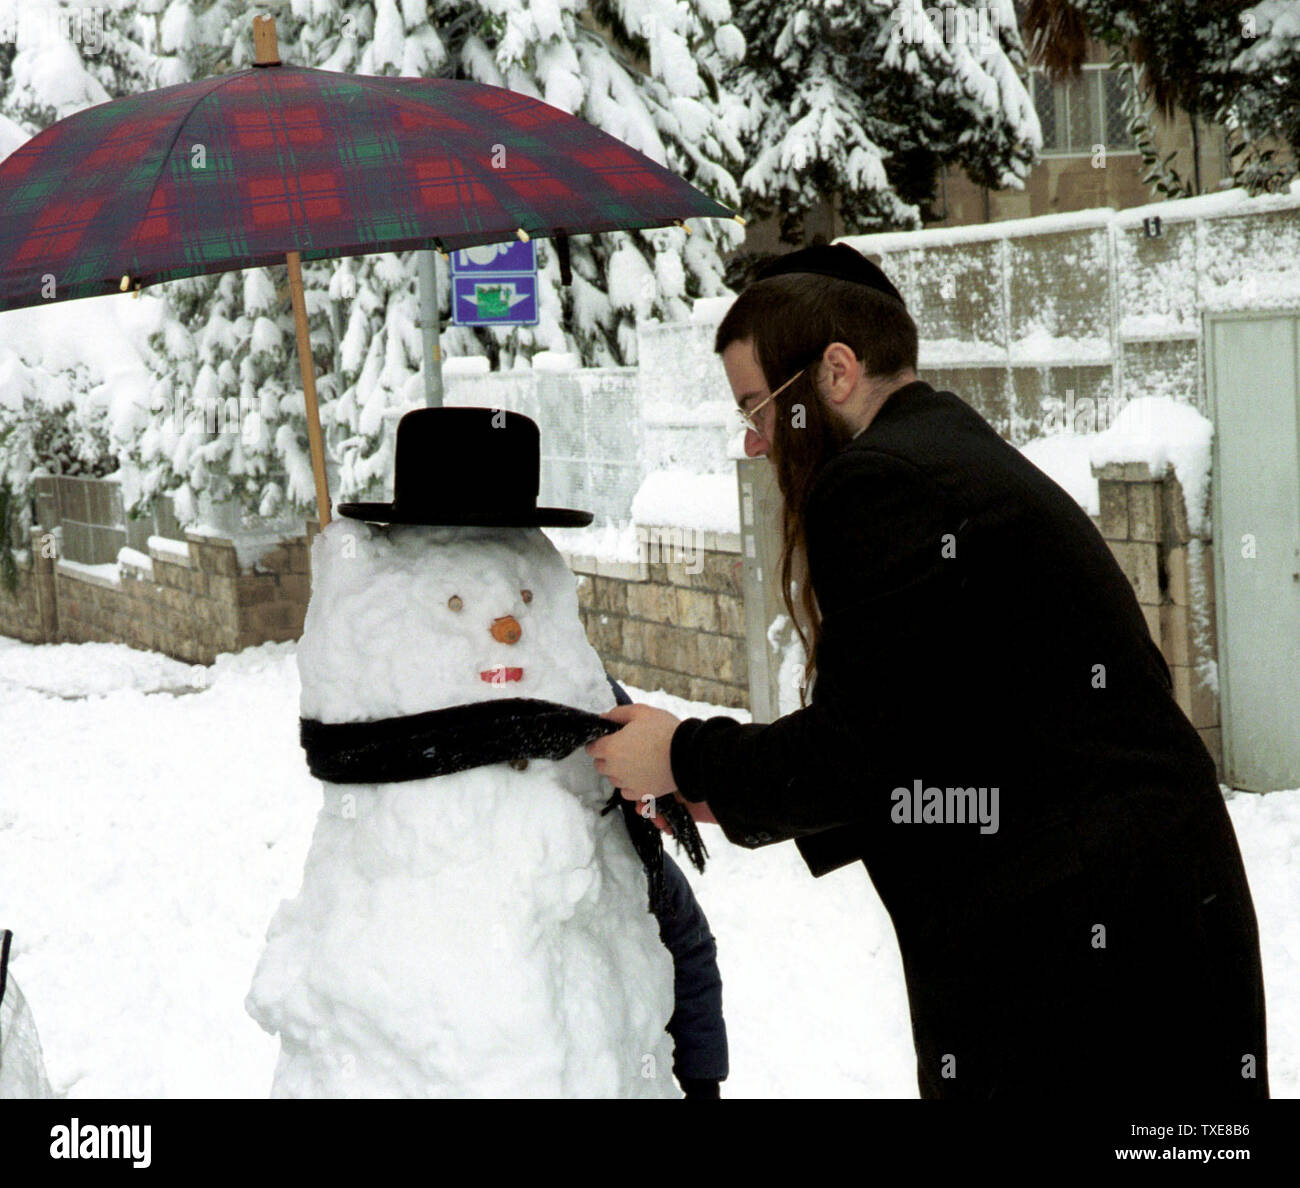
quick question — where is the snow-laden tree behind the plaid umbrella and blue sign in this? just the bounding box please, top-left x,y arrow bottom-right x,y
134,0 -> 744,515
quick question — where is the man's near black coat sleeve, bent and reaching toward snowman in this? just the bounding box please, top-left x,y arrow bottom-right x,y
671,448 -> 962,864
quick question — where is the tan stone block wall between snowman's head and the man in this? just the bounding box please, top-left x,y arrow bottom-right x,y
568,526 -> 749,707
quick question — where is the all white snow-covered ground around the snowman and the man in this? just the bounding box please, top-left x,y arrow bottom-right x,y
0,638 -> 1300,1097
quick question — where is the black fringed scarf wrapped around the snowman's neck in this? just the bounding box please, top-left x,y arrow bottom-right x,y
299,697 -> 707,918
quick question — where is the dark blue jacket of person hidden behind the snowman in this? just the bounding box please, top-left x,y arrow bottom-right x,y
606,675 -> 728,1080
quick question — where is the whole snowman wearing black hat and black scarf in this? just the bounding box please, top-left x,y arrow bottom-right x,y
246,408 -> 679,1097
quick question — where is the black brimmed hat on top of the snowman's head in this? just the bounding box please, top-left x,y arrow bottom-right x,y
338,407 -> 592,528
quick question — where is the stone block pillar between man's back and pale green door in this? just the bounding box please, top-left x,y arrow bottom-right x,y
1093,463 -> 1223,773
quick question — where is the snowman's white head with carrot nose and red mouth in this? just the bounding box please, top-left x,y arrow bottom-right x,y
298,520 -> 610,721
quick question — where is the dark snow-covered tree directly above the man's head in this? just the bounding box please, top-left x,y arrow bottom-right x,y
724,0 -> 1043,243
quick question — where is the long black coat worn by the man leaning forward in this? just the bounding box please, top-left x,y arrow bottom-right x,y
672,382 -> 1268,1098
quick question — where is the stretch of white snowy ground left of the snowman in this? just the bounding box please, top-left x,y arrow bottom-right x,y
0,643 -> 309,1097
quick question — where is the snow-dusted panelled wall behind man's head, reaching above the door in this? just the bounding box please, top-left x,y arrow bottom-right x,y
839,185 -> 1300,445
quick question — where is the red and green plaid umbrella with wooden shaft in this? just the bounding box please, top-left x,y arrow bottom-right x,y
0,18 -> 736,524
